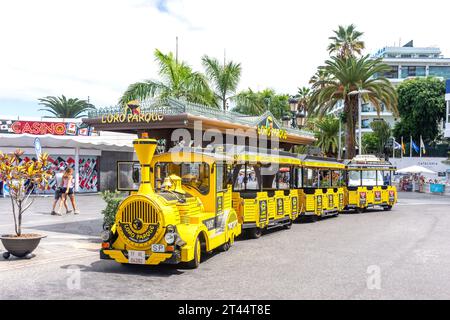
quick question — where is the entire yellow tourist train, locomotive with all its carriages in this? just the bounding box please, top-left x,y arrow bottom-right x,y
100,138 -> 396,268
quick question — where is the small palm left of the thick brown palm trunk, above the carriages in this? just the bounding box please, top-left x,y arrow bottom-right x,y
314,116 -> 339,157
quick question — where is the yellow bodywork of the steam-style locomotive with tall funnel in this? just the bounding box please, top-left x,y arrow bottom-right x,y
102,139 -> 241,265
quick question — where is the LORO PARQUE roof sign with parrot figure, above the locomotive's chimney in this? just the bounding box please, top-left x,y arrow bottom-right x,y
102,100 -> 164,123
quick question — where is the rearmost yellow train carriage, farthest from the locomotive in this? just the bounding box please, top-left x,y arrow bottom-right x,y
344,155 -> 397,212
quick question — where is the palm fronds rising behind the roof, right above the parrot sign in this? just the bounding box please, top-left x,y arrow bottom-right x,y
119,49 -> 216,106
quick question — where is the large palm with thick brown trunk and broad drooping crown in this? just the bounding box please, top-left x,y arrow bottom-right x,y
311,56 -> 398,158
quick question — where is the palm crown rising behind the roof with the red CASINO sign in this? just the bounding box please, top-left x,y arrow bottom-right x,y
38,95 -> 95,119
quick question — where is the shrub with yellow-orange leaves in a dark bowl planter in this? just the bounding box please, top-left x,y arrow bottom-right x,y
0,150 -> 52,259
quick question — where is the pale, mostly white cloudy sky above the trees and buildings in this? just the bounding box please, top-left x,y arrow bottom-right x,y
0,0 -> 450,116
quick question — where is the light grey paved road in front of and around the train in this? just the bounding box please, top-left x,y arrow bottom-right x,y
0,193 -> 450,299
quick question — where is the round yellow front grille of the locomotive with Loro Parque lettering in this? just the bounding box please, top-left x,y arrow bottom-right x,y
117,196 -> 163,249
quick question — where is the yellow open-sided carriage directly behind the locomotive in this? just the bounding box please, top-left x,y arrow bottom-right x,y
232,146 -> 301,238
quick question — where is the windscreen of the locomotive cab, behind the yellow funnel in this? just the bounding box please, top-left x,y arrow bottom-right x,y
157,162 -> 210,194
